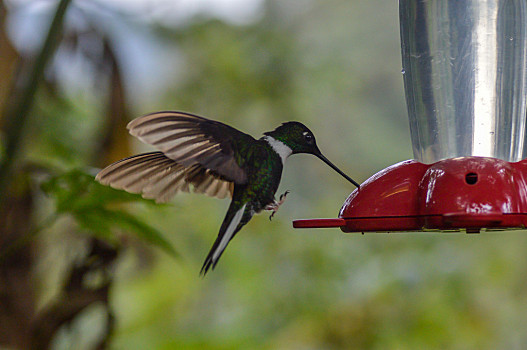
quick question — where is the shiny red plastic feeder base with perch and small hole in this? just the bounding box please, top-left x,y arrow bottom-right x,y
293,157 -> 527,233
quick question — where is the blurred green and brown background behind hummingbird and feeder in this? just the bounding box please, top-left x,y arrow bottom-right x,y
0,0 -> 527,349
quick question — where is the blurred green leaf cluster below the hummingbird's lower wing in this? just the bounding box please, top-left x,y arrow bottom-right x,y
41,170 -> 178,256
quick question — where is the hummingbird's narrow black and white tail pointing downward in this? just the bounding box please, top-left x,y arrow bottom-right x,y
200,201 -> 252,276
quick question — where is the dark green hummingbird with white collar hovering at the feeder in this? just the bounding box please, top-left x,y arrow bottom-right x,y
95,111 -> 359,276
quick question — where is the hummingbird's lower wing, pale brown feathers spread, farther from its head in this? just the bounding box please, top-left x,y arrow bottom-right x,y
95,152 -> 234,202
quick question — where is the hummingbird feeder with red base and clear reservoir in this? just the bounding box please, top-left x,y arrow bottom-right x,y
293,0 -> 527,233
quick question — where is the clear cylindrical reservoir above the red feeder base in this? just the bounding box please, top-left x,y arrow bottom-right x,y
399,0 -> 527,163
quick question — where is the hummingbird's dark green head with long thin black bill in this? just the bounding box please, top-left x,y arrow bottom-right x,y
264,122 -> 360,187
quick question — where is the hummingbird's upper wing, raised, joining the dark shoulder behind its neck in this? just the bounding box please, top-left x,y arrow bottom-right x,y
127,111 -> 255,184
